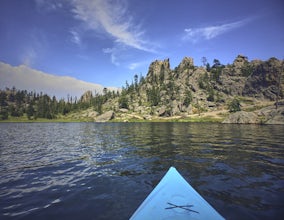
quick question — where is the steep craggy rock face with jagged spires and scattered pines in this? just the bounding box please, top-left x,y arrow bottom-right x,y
83,55 -> 284,121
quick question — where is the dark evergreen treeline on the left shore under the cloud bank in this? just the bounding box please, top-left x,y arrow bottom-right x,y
0,87 -> 119,120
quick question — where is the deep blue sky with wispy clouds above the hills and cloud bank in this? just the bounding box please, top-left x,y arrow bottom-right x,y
0,0 -> 284,87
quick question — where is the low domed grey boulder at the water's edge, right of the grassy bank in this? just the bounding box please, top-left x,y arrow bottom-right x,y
223,111 -> 258,124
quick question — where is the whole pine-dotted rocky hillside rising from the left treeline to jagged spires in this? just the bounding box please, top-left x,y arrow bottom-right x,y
0,55 -> 284,121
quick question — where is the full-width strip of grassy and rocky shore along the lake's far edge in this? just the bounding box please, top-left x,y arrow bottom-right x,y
0,105 -> 284,124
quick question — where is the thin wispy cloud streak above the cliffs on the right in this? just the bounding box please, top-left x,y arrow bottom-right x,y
183,19 -> 248,43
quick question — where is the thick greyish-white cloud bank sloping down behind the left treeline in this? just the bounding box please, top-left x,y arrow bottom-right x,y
0,62 -> 116,98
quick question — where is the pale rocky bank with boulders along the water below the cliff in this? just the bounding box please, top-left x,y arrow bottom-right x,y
62,101 -> 284,124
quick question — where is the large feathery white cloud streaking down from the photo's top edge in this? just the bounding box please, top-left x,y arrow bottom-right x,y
72,0 -> 154,52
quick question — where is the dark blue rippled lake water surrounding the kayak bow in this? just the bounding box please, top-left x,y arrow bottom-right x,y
0,123 -> 284,220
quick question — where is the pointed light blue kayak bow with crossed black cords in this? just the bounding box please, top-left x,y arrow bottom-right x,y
130,167 -> 224,220
